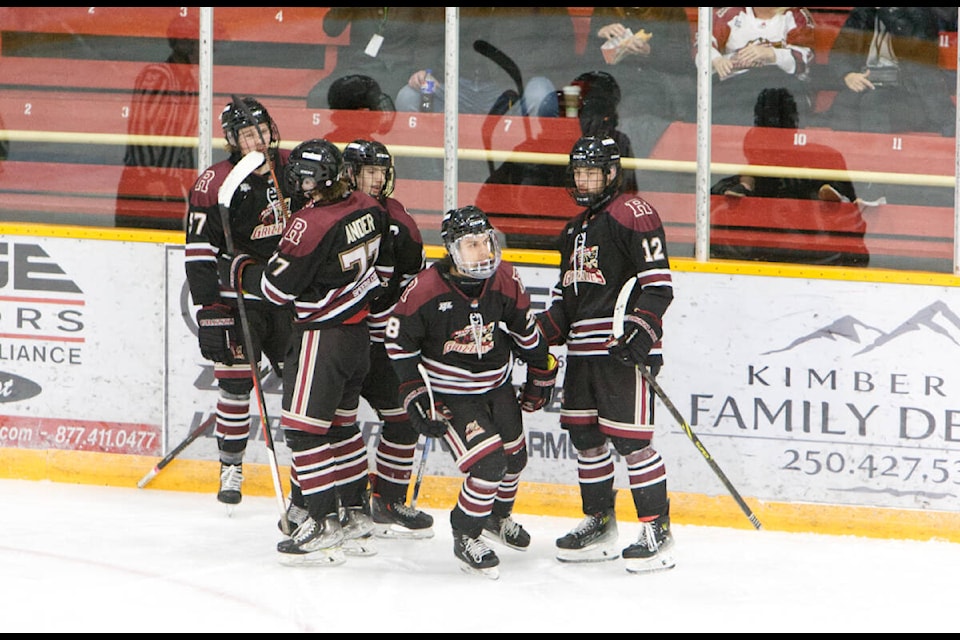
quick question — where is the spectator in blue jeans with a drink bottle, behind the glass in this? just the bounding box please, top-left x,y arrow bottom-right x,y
396,7 -> 576,117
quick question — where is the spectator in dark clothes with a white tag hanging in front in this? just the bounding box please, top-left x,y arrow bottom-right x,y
307,7 -> 443,109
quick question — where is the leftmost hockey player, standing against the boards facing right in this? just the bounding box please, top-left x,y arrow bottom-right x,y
186,98 -> 293,508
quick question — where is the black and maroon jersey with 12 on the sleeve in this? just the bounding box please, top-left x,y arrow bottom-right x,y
540,193 -> 673,365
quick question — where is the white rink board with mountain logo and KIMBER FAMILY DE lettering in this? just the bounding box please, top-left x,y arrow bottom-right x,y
171,252 -> 960,511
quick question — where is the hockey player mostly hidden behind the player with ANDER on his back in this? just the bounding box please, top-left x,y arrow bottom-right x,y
343,139 -> 433,538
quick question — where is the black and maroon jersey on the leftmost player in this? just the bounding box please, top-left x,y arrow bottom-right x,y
185,149 -> 290,306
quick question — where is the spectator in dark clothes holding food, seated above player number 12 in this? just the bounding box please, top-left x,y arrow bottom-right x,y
584,7 -> 697,127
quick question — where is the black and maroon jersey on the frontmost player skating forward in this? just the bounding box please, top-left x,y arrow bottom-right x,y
386,256 -> 548,394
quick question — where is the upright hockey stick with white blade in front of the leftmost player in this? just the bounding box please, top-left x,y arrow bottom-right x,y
217,151 -> 290,535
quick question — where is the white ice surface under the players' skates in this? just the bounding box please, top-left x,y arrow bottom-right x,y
0,480 -> 960,633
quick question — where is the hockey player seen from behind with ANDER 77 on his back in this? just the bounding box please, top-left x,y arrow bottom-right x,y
220,139 -> 393,565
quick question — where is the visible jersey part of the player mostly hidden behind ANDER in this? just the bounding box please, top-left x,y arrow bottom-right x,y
367,198 -> 426,342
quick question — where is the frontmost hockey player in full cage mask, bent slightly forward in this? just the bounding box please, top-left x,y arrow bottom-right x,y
386,206 -> 557,578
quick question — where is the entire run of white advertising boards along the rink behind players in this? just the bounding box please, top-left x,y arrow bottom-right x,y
0,237 -> 960,511
